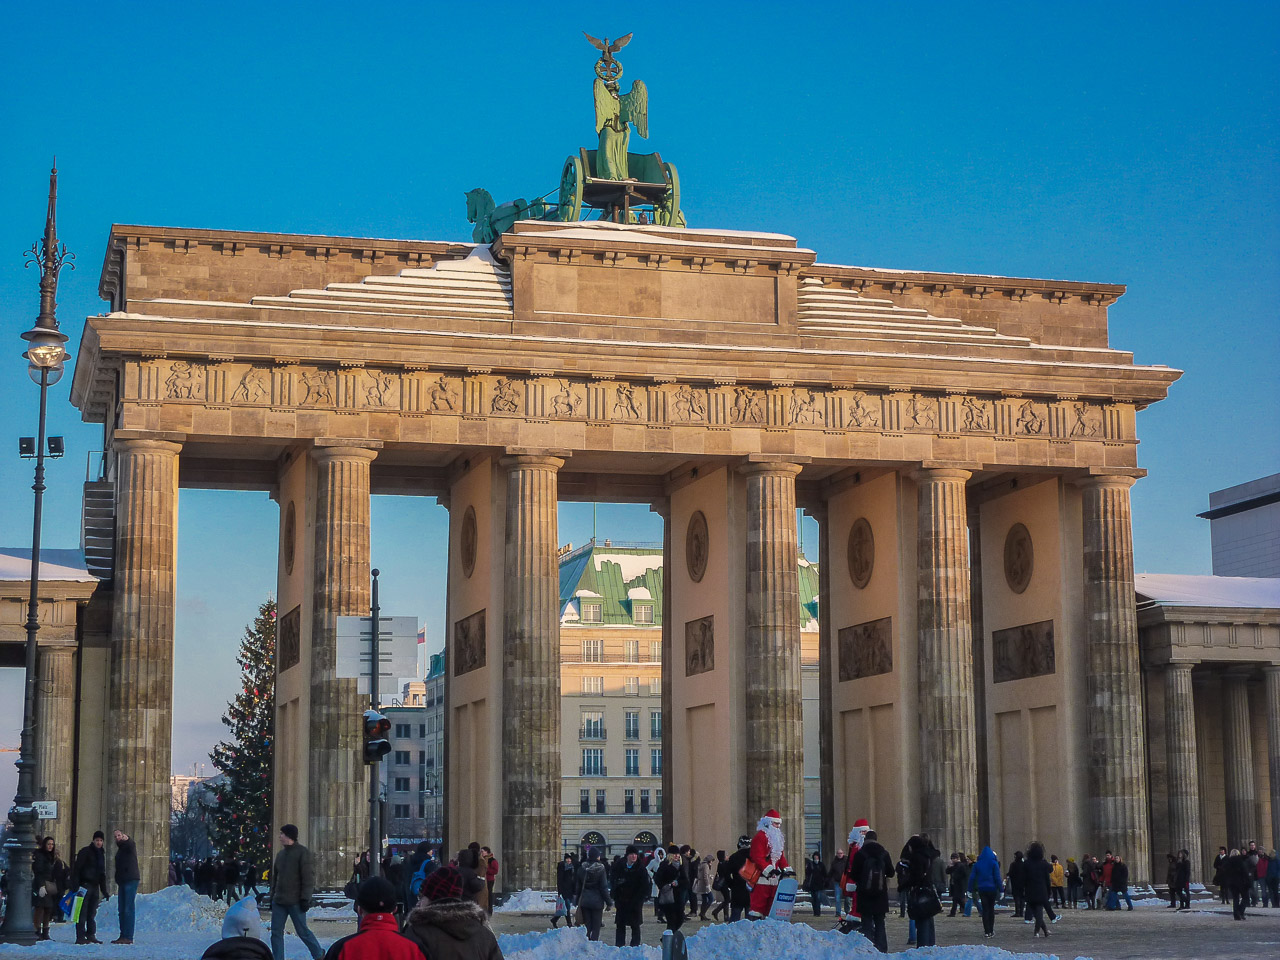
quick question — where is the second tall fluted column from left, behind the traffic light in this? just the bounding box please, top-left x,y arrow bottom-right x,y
308,443 -> 378,888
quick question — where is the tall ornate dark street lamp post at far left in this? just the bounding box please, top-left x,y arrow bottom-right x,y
0,165 -> 74,945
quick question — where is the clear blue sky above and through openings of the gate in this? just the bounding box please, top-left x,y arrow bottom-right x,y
0,3 -> 1280,796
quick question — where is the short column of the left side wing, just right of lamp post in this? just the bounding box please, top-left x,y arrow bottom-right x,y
36,645 -> 76,846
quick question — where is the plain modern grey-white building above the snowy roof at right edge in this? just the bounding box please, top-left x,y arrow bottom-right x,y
1199,474 -> 1280,577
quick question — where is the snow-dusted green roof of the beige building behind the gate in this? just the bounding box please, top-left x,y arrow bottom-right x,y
559,540 -> 818,626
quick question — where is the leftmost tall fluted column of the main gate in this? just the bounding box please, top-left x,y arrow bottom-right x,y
106,439 -> 180,892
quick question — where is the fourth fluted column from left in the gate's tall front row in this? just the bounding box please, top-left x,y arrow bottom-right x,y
742,462 -> 804,856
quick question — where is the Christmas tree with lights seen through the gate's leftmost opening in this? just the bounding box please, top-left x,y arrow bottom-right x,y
209,600 -> 275,872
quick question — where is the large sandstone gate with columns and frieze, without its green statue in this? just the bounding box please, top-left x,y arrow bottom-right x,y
64,223 -> 1179,888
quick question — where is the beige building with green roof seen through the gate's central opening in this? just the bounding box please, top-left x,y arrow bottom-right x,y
559,540 -> 822,855
